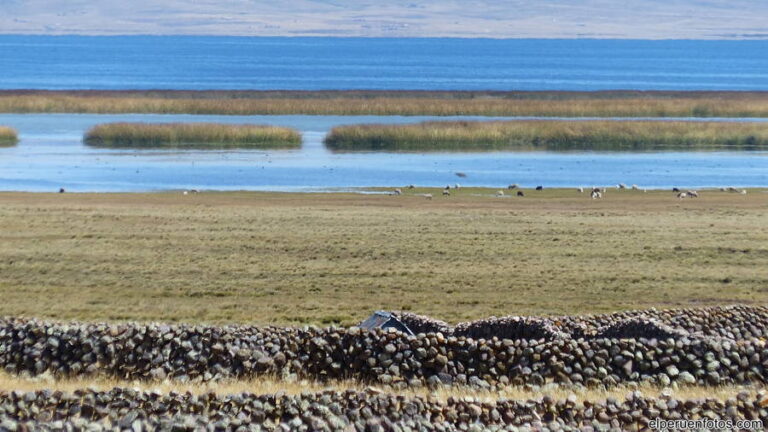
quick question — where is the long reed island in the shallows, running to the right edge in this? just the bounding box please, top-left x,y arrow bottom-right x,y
325,120 -> 768,151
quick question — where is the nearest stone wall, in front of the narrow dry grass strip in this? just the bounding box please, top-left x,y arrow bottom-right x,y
0,388 -> 768,432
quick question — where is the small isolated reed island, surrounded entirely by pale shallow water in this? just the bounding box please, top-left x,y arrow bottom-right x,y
83,123 -> 301,149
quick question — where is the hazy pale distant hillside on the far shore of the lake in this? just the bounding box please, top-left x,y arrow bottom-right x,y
0,0 -> 768,39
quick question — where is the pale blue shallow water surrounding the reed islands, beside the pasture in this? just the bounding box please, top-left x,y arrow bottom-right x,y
0,114 -> 768,192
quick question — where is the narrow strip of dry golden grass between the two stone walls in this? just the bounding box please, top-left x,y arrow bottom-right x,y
0,372 -> 765,402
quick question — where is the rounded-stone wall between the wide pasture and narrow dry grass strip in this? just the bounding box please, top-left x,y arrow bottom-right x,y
0,308 -> 768,388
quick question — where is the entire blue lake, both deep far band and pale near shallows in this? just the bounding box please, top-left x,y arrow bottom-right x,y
0,35 -> 768,191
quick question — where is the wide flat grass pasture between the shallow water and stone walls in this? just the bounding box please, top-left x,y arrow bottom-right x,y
0,188 -> 768,325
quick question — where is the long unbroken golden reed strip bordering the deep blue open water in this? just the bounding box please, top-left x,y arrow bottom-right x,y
0,91 -> 768,117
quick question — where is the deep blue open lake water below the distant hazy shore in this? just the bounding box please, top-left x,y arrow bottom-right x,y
0,35 -> 768,90
